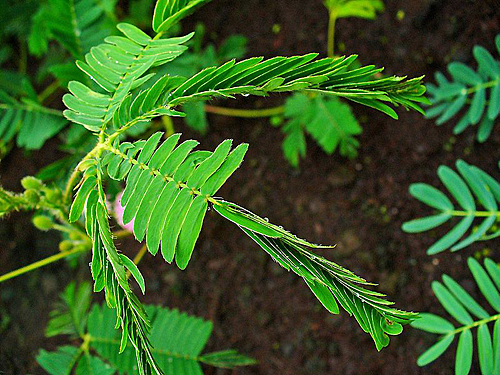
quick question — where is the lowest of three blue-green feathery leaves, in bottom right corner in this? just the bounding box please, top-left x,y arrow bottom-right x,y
412,258 -> 500,375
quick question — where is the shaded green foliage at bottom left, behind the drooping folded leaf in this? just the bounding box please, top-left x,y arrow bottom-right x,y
37,283 -> 255,375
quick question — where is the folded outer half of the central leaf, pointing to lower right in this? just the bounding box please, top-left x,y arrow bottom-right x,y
213,200 -> 416,350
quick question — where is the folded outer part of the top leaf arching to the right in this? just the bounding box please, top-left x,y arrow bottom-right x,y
166,53 -> 425,118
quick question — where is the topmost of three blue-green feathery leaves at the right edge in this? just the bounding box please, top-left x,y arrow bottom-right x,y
427,35 -> 500,142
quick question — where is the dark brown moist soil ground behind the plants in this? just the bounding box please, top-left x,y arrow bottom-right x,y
0,0 -> 500,375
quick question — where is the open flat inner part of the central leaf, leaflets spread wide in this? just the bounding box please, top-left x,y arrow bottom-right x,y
97,133 -> 248,269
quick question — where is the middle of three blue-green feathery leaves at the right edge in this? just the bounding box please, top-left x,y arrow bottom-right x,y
403,160 -> 500,254
